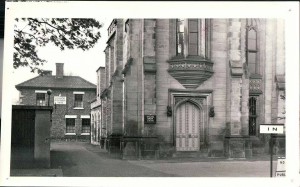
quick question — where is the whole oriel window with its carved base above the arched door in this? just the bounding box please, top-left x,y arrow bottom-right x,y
168,19 -> 214,89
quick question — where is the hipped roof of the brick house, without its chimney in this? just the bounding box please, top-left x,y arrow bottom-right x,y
16,75 -> 97,90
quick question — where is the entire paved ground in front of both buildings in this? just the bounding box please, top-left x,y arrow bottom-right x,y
51,142 -> 276,177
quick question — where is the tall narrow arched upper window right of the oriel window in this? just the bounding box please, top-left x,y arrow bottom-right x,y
246,19 -> 259,74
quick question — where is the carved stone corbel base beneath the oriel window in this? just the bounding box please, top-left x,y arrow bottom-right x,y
168,56 -> 214,89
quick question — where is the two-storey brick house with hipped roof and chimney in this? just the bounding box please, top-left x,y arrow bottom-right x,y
16,63 -> 96,140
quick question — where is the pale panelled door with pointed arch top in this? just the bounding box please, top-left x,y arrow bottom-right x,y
175,101 -> 201,151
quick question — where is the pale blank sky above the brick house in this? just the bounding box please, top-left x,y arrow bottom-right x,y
13,18 -> 112,104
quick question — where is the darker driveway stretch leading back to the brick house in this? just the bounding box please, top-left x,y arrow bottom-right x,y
51,142 -> 175,177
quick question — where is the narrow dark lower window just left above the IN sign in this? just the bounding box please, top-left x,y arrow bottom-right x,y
249,97 -> 257,136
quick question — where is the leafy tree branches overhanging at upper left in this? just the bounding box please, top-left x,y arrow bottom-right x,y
13,18 -> 102,74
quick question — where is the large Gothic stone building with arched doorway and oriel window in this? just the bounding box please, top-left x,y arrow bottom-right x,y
100,19 -> 285,158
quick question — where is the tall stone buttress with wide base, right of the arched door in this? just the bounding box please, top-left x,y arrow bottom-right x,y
225,19 -> 250,158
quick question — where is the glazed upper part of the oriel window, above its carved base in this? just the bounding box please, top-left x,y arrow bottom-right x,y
176,19 -> 210,58
